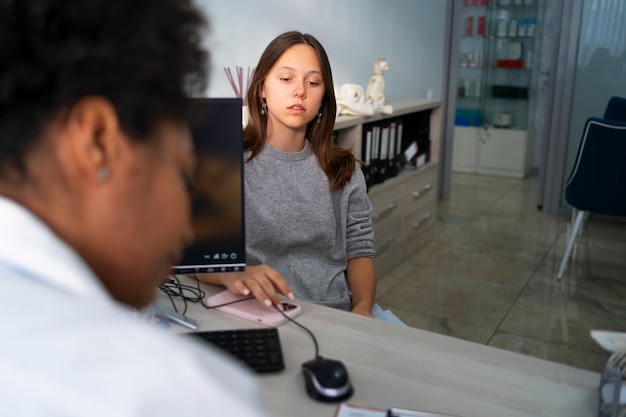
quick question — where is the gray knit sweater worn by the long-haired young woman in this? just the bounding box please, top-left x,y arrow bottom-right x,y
244,140 -> 375,311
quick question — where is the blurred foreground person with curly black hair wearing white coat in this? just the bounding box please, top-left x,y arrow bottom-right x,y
0,0 -> 263,417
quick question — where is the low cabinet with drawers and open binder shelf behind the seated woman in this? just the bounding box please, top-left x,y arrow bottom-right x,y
334,98 -> 443,277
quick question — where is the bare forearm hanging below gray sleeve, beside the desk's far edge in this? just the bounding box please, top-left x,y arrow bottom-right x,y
346,257 -> 376,317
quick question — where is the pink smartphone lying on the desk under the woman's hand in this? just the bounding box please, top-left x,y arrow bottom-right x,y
206,290 -> 302,327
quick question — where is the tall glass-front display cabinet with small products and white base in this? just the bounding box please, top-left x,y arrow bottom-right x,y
453,0 -> 539,177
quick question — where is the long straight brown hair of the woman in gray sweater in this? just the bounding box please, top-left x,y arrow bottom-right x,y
243,31 -> 356,191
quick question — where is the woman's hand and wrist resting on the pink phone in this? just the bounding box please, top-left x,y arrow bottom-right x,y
197,265 -> 294,307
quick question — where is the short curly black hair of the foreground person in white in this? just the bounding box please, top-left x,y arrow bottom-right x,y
0,0 -> 209,177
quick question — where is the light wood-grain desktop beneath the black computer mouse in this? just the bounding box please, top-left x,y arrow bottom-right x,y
158,284 -> 600,417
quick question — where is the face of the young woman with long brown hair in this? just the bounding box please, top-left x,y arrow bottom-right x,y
261,44 -> 325,131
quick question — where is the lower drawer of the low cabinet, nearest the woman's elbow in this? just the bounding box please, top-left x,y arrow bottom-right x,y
374,216 -> 403,278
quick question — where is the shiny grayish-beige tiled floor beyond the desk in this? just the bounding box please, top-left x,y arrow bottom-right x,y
377,173 -> 626,371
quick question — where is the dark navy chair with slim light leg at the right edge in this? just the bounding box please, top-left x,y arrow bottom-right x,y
557,97 -> 626,280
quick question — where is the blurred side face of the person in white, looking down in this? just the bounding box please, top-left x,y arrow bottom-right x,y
95,122 -> 195,307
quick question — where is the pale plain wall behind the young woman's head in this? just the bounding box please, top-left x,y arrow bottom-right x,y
195,0 -> 446,98
